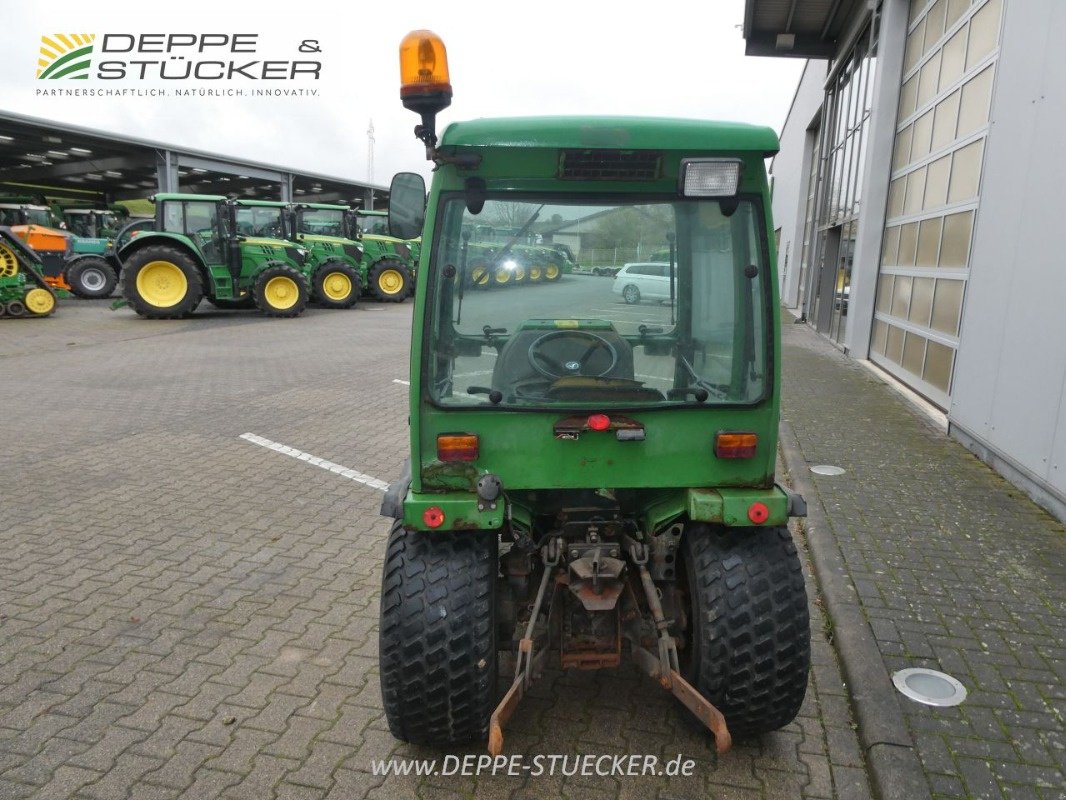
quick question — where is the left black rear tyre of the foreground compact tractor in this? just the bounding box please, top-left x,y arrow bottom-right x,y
378,522 -> 498,747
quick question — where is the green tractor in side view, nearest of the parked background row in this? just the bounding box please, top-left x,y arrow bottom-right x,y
118,193 -> 310,319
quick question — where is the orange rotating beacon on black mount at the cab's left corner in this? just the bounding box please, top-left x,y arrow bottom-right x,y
400,30 -> 452,161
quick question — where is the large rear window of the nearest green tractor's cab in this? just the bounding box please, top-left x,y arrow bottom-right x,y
425,196 -> 771,407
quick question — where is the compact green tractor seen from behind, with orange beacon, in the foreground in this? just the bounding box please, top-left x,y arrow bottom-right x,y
379,31 -> 810,755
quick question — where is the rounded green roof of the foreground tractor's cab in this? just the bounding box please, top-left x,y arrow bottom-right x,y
440,116 -> 779,156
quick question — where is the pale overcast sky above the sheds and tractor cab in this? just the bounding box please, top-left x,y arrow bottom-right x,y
0,0 -> 803,185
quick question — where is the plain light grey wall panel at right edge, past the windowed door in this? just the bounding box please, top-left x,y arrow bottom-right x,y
949,0 -> 1066,516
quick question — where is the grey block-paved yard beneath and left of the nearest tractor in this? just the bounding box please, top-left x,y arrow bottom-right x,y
0,288 -> 871,800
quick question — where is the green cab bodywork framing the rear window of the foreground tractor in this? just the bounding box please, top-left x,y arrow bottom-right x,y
405,117 -> 787,529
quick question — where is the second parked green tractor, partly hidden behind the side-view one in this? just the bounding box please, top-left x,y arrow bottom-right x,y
235,199 -> 362,308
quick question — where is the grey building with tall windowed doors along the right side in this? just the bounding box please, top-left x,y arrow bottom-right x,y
744,0 -> 1066,518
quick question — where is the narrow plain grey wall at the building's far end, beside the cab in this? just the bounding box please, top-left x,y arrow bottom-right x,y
771,61 -> 828,308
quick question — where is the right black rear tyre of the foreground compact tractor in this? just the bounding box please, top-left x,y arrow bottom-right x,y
679,523 -> 810,737
